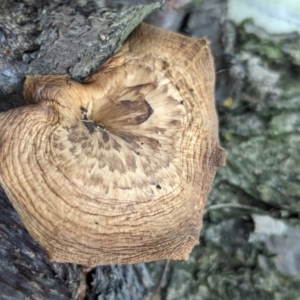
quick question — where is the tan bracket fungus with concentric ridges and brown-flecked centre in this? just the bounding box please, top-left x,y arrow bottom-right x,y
0,24 -> 226,266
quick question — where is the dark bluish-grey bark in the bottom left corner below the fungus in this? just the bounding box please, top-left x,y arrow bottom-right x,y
0,189 -> 80,300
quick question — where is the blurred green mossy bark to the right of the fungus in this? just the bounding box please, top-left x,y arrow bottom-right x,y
150,8 -> 300,300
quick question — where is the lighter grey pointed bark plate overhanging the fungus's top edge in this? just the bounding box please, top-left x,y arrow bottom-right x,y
29,1 -> 162,79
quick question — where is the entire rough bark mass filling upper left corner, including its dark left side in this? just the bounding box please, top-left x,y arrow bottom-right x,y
0,0 -> 163,95
